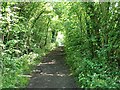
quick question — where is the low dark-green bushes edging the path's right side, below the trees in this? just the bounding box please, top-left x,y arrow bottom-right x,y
65,30 -> 120,88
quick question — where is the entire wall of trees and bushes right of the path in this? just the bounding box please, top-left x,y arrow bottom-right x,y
64,2 -> 120,88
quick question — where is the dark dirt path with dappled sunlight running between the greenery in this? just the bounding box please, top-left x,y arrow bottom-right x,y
28,47 -> 77,88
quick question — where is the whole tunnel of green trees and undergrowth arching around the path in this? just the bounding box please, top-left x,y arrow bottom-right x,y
0,2 -> 120,88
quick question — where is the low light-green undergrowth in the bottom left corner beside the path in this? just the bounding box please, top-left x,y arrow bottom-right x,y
2,53 -> 37,88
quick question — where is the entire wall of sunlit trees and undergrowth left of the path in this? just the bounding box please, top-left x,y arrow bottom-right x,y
0,2 -> 56,88
